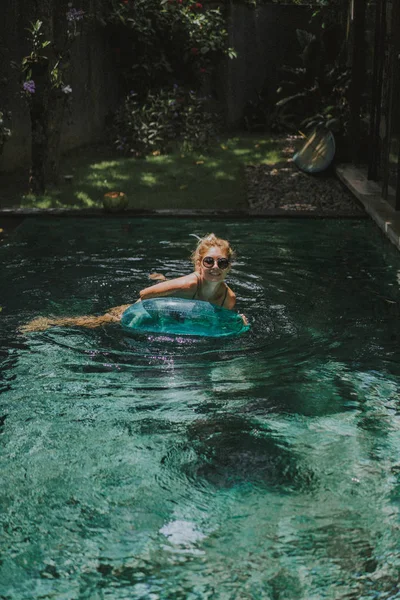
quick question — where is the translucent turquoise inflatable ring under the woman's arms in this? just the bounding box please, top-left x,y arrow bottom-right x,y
121,298 -> 249,337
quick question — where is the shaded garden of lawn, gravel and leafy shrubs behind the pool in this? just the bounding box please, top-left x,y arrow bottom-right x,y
0,0 -> 357,214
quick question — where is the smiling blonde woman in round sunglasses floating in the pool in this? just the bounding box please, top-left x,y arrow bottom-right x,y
20,233 -> 247,333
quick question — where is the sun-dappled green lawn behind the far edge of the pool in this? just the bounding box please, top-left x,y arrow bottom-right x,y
0,135 -> 288,209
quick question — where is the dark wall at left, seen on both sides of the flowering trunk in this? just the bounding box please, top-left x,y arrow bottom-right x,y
0,0 -> 118,171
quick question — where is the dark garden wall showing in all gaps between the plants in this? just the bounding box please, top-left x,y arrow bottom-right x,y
0,0 -> 312,171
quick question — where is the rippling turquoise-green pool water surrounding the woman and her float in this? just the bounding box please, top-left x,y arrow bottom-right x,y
0,219 -> 400,600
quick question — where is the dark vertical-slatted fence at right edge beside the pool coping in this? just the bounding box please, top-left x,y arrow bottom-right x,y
362,0 -> 400,210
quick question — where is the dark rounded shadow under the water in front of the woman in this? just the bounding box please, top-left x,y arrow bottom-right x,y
166,415 -> 318,493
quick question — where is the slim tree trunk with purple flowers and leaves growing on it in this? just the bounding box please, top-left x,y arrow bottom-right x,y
21,0 -> 85,194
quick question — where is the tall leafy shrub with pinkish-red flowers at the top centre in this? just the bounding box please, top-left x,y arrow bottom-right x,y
105,0 -> 235,94
